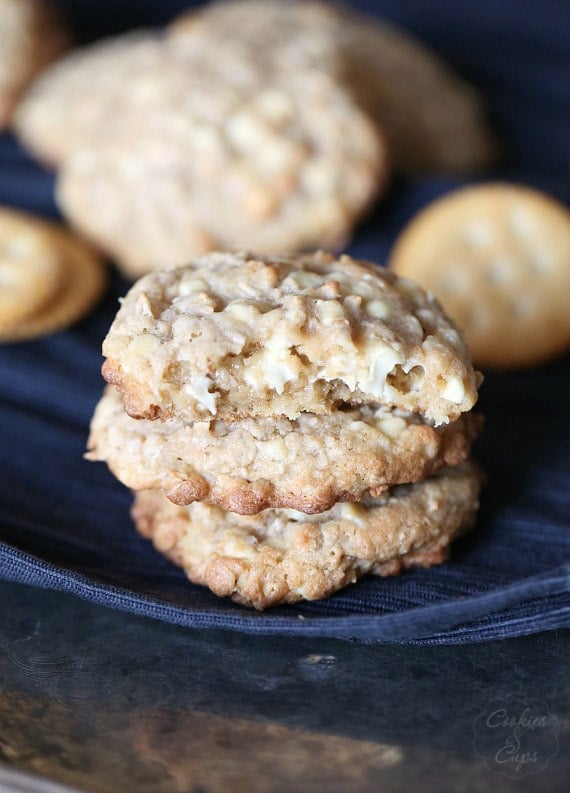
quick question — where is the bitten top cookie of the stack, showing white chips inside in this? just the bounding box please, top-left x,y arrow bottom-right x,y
103,253 -> 478,424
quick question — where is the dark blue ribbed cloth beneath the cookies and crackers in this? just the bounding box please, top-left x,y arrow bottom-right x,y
0,0 -> 570,644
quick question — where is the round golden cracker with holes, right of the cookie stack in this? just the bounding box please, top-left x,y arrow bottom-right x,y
390,183 -> 570,368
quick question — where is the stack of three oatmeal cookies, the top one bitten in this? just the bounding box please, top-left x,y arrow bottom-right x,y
88,253 -> 480,608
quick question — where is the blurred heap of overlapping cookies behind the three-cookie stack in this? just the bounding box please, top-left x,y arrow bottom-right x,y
14,0 -> 495,278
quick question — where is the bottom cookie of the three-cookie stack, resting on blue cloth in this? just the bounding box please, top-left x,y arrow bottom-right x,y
132,462 -> 481,609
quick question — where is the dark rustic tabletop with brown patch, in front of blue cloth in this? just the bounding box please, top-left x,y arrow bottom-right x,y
0,582 -> 570,793
